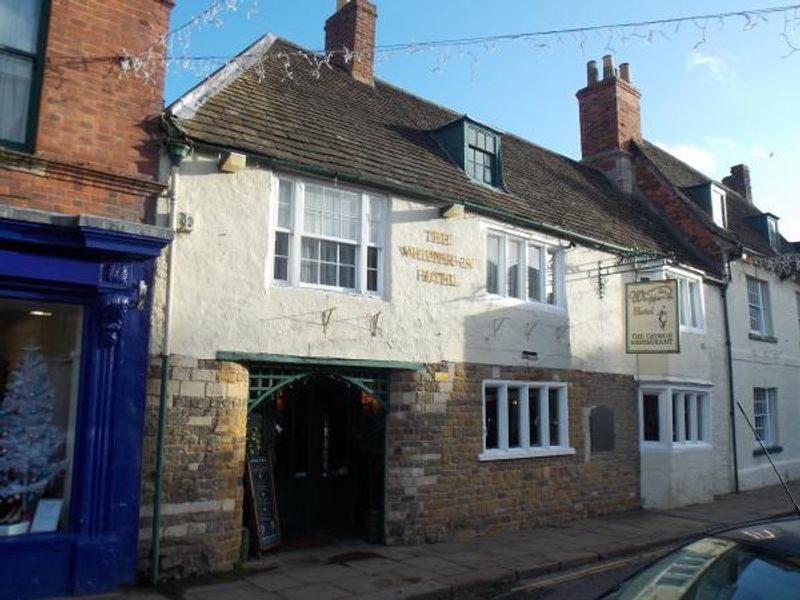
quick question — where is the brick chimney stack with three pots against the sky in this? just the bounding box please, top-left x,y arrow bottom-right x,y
576,55 -> 642,162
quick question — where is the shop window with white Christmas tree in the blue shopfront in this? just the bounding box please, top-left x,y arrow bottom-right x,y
0,298 -> 82,535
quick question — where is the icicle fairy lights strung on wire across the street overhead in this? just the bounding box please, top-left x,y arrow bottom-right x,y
45,0 -> 800,82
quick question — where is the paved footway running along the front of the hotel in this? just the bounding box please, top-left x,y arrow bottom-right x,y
104,481 -> 800,600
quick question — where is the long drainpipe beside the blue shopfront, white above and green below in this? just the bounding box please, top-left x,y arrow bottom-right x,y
150,141 -> 189,586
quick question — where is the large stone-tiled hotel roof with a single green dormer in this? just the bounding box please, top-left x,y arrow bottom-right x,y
170,39 -> 686,260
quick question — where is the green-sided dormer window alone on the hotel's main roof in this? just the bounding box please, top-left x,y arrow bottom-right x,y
432,116 -> 503,188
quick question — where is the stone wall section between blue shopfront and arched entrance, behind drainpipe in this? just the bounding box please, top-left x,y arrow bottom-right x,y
139,356 -> 248,579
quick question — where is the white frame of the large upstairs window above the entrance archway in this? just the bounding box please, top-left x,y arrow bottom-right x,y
265,174 -> 391,297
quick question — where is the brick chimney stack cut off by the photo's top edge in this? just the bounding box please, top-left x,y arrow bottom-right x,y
325,0 -> 378,85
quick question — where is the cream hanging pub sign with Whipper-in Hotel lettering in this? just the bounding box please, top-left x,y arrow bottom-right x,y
625,279 -> 681,354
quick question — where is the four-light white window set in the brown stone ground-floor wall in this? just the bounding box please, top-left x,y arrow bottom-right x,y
480,381 -> 575,460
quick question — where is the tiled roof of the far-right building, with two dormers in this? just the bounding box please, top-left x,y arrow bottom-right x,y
635,140 -> 792,256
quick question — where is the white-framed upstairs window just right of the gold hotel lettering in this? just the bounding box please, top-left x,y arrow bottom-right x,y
486,231 -> 564,306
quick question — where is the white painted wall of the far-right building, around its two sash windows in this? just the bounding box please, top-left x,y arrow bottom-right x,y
729,261 -> 800,489
